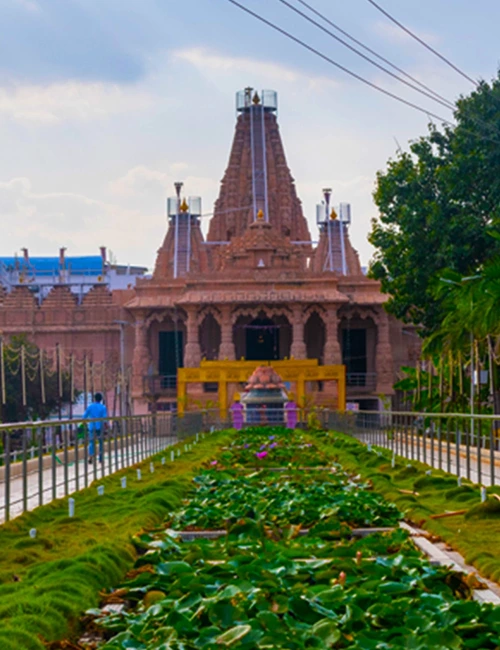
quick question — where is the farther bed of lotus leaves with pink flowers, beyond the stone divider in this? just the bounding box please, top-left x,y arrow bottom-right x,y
171,430 -> 400,534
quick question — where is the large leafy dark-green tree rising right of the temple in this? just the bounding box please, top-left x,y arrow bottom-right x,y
369,76 -> 500,335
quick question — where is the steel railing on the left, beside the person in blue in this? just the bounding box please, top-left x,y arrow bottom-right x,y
0,413 -> 179,523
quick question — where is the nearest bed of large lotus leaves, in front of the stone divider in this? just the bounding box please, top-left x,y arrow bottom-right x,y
96,531 -> 500,650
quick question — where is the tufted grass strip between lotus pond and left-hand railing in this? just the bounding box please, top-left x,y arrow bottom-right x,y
0,432 -> 229,650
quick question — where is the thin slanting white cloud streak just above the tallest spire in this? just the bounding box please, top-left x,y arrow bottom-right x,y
171,47 -> 339,87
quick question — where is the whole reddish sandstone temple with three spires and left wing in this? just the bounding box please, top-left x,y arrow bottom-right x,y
0,88 -> 418,413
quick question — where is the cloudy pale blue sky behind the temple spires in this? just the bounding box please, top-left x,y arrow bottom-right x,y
0,0 -> 500,267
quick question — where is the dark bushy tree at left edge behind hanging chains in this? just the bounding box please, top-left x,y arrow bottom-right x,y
0,335 -> 70,422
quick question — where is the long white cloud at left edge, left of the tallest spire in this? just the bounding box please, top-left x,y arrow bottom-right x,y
0,81 -> 153,124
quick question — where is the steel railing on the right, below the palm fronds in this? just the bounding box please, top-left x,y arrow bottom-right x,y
328,411 -> 500,486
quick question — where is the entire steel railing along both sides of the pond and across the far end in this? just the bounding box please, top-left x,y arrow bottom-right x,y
4,407 -> 500,523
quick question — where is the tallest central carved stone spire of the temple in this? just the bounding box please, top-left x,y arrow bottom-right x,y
207,88 -> 310,242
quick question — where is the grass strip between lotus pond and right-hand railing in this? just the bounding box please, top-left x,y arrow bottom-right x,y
318,433 -> 500,582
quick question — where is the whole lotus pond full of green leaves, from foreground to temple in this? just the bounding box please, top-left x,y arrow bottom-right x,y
90,429 -> 500,650
